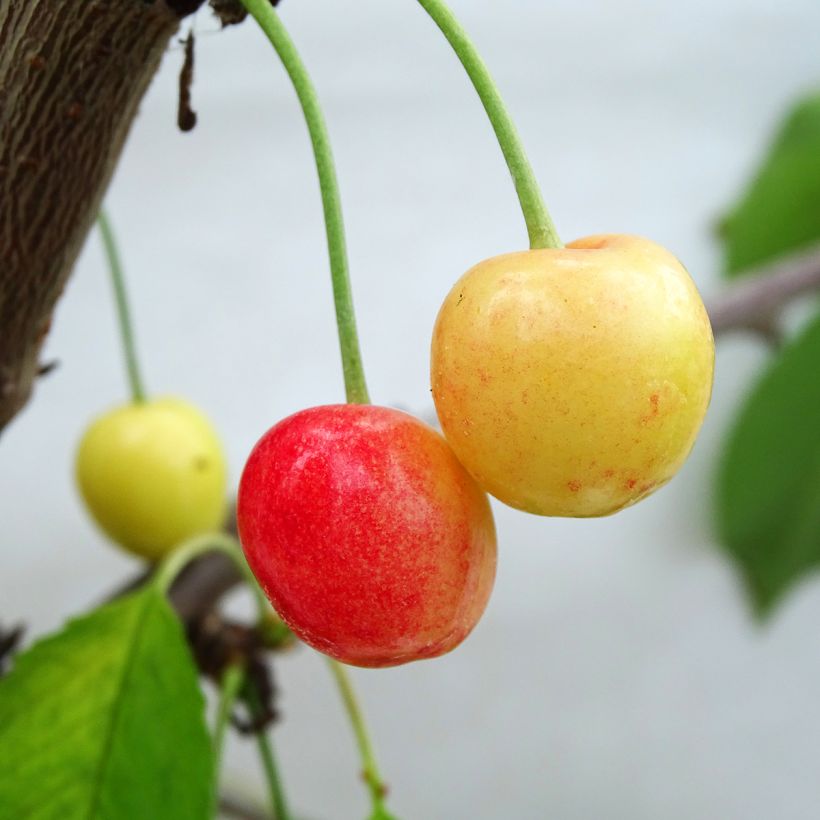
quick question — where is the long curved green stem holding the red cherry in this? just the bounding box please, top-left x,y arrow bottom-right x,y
242,0 -> 369,404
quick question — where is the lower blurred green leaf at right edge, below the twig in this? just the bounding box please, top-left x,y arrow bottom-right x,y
717,316 -> 820,615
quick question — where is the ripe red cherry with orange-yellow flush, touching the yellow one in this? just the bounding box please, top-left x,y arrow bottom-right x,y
237,404 -> 496,667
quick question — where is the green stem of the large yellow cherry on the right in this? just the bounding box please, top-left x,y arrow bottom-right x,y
418,0 -> 563,249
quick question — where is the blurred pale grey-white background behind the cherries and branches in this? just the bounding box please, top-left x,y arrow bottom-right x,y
0,0 -> 820,820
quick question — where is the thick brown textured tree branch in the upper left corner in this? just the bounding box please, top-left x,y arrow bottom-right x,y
0,0 -> 186,429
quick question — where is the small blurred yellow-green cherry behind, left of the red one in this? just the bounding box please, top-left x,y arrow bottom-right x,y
76,398 -> 227,561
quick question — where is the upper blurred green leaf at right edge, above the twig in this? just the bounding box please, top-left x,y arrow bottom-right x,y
721,93 -> 820,276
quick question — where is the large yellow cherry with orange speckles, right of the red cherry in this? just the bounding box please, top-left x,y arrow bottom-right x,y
431,235 -> 715,517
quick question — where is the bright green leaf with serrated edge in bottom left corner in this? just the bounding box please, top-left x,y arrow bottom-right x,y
0,587 -> 214,820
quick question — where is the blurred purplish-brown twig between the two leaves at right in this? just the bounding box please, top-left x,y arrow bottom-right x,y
709,240 -> 820,336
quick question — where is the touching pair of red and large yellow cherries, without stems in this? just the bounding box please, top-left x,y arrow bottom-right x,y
238,236 -> 714,666
